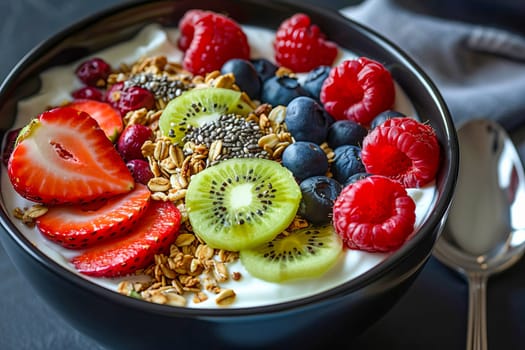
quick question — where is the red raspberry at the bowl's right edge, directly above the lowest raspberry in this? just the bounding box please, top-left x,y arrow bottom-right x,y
361,117 -> 440,188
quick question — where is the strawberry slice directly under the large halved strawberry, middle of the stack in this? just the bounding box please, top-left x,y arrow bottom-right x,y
36,184 -> 151,249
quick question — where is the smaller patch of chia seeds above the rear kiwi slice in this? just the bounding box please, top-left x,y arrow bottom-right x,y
124,73 -> 194,102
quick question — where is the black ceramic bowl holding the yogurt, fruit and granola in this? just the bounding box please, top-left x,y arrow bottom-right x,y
0,0 -> 458,349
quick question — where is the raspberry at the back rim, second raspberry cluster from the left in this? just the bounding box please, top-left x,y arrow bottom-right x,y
274,13 -> 338,72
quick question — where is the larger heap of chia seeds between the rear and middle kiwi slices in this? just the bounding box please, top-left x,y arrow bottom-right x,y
183,114 -> 270,165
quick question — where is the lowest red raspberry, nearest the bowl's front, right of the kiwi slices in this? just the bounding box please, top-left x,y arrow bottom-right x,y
333,175 -> 416,252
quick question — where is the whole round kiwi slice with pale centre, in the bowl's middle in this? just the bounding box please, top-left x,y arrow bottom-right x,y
186,158 -> 301,251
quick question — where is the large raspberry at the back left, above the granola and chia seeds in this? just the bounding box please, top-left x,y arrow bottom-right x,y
179,10 -> 250,75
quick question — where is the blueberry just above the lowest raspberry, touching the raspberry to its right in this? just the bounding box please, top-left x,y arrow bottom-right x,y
331,145 -> 366,183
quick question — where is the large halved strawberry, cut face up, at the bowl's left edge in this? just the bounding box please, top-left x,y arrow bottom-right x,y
7,107 -> 135,205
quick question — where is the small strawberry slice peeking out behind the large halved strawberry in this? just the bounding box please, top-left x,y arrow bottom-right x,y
66,99 -> 124,142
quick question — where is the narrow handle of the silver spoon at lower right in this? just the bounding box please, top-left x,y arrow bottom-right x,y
467,272 -> 487,350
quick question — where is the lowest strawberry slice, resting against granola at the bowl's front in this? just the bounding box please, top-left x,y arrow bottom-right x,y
71,201 -> 181,277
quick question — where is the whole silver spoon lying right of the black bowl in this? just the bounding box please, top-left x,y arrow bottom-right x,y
433,119 -> 525,350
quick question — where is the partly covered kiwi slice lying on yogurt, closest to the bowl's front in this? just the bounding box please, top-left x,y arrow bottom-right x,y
239,224 -> 343,282
